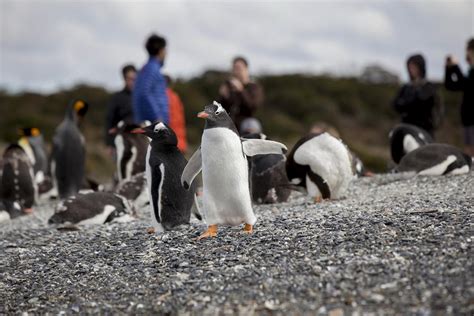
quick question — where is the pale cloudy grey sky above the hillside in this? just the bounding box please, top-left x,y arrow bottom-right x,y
0,0 -> 474,92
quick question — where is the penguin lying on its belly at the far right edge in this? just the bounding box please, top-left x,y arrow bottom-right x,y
396,144 -> 472,176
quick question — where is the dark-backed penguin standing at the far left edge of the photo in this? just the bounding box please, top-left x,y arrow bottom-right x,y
0,144 -> 37,213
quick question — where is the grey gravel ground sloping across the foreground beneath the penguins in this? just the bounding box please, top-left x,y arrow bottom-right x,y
0,172 -> 474,316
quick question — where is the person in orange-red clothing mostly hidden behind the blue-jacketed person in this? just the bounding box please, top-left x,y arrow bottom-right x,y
165,75 -> 188,153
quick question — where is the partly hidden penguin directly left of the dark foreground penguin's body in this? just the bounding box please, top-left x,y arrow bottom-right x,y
115,172 -> 150,209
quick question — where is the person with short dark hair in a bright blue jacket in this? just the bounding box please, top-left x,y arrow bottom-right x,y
132,34 -> 169,124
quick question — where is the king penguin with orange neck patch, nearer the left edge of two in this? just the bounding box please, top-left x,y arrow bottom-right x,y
18,127 -> 49,185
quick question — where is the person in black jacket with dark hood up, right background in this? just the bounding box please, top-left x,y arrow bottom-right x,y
393,54 -> 442,136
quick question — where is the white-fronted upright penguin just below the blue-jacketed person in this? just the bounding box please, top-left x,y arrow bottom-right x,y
109,121 -> 149,182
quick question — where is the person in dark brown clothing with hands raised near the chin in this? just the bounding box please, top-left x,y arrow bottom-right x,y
218,56 -> 263,131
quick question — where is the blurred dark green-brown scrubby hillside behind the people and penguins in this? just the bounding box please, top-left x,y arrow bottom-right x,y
0,71 -> 462,181
